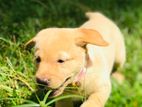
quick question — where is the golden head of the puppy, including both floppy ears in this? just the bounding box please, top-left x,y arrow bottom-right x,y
26,28 -> 107,96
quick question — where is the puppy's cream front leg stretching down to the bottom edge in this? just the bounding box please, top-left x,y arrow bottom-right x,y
81,83 -> 111,107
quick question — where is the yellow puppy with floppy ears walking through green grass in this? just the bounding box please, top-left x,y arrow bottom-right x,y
27,12 -> 125,107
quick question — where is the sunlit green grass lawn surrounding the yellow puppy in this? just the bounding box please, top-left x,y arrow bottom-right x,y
0,0 -> 142,107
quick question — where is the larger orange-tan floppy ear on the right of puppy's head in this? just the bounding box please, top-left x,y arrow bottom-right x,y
77,28 -> 108,46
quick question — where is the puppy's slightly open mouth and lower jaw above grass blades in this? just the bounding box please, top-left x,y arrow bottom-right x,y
49,77 -> 71,97
